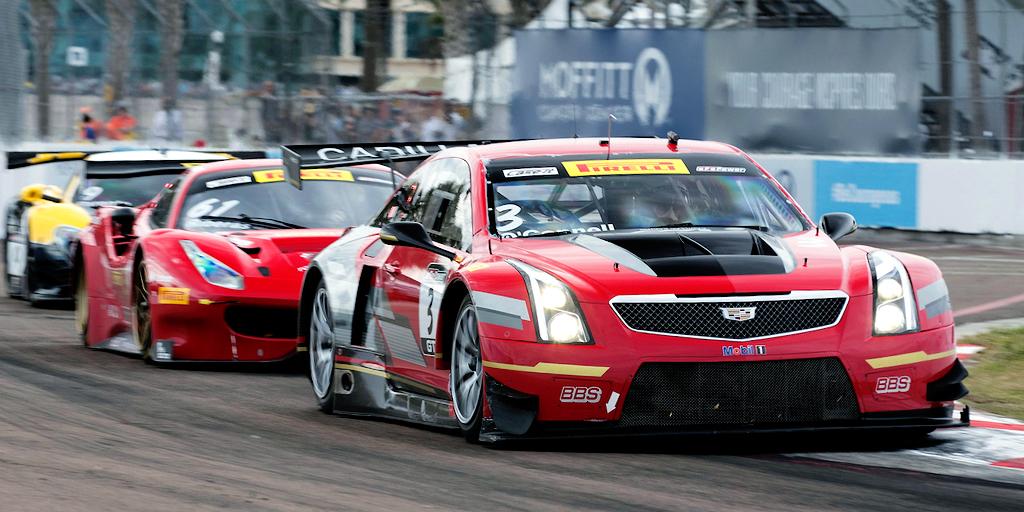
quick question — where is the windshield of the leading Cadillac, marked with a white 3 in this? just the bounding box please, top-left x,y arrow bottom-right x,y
492,159 -> 807,238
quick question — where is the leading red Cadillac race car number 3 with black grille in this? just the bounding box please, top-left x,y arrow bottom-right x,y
285,138 -> 969,440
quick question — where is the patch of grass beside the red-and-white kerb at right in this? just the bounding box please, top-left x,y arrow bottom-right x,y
959,329 -> 1024,419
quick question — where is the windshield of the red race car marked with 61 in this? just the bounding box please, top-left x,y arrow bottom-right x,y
178,169 -> 392,231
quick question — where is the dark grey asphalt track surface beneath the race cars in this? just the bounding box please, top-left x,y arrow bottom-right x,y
6,237 -> 1024,512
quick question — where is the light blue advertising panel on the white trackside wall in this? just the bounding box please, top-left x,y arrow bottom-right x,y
814,160 -> 918,228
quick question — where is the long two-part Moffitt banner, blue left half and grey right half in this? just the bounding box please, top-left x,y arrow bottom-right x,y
511,29 -> 921,155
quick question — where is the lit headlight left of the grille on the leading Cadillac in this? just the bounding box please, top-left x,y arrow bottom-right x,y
508,260 -> 590,343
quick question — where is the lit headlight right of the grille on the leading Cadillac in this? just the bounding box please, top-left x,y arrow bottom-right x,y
867,251 -> 918,336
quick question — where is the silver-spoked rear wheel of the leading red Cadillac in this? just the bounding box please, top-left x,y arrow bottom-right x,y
306,281 -> 335,414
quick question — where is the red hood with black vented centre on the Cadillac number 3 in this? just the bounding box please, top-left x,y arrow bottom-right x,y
493,228 -> 870,302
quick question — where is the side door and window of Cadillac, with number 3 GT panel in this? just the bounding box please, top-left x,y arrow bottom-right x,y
377,158 -> 472,394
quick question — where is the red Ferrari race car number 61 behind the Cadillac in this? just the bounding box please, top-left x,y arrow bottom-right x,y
75,160 -> 401,362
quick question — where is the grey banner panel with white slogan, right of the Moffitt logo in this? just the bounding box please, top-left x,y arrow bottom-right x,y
705,29 -> 921,155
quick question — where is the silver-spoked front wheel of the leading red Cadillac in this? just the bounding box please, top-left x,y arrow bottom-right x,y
449,296 -> 484,442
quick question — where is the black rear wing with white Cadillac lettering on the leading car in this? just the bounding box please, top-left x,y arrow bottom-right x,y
281,140 -> 510,190
